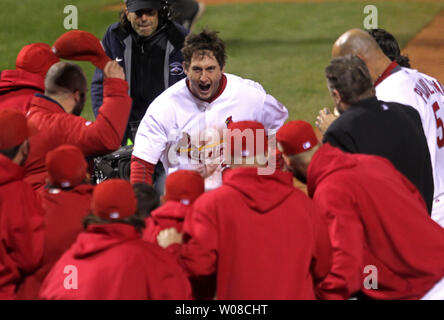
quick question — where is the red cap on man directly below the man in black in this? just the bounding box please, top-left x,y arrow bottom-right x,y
276,120 -> 319,155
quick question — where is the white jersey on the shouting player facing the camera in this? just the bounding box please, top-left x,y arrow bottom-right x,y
133,73 -> 288,190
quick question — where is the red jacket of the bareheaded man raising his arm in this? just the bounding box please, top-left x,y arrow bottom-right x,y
25,78 -> 131,189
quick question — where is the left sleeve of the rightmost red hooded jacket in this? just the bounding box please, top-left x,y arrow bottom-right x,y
314,185 -> 364,300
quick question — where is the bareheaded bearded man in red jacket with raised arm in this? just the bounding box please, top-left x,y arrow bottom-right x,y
25,61 -> 131,189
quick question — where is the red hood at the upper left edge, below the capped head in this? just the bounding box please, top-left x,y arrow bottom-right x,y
0,70 -> 45,94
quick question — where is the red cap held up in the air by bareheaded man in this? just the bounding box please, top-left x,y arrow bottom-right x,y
52,30 -> 111,70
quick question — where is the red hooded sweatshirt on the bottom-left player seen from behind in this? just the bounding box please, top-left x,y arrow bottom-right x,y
40,223 -> 191,300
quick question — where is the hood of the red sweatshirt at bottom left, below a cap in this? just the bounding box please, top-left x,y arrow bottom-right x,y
72,223 -> 141,259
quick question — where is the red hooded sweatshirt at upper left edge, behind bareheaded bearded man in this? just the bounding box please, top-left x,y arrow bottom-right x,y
0,70 -> 45,114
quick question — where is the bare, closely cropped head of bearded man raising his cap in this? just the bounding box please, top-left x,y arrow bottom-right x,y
45,62 -> 88,97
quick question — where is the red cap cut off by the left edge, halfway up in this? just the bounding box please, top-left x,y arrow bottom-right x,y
0,108 -> 38,150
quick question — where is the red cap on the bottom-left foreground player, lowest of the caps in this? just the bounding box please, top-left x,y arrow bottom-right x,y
91,179 -> 137,220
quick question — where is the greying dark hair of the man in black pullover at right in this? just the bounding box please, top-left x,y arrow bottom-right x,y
325,55 -> 373,104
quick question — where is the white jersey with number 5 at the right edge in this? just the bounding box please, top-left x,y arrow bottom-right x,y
376,67 -> 444,226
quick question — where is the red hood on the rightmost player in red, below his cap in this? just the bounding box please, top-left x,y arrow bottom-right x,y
307,143 -> 357,198
